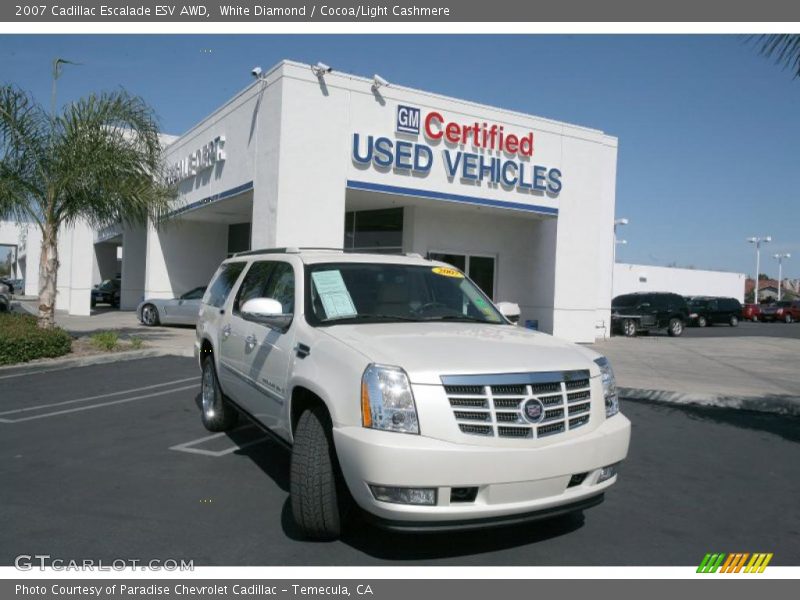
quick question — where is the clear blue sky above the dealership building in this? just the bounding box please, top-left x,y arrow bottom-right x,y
0,34 -> 800,277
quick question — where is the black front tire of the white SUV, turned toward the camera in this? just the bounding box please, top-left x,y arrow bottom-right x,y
289,406 -> 349,540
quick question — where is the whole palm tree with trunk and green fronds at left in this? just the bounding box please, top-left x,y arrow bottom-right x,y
0,85 -> 174,328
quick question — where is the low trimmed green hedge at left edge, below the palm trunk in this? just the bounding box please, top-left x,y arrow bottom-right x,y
0,313 -> 72,365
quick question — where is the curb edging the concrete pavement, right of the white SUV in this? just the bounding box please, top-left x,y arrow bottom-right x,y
617,387 -> 800,417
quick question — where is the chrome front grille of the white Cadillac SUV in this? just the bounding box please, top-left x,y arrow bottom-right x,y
442,371 -> 591,439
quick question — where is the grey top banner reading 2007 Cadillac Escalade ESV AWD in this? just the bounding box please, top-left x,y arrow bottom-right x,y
0,0 -> 800,23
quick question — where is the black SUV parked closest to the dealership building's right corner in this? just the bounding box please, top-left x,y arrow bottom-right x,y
611,292 -> 689,337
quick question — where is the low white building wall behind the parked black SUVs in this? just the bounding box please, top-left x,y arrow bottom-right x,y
614,263 -> 745,302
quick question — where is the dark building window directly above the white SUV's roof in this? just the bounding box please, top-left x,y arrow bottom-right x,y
344,208 -> 403,253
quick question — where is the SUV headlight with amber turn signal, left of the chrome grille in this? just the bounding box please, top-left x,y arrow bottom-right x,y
361,365 -> 419,433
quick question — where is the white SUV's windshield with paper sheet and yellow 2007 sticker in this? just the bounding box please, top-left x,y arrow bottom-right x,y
306,263 -> 506,325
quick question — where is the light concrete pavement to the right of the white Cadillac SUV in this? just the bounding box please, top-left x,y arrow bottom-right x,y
592,336 -> 800,416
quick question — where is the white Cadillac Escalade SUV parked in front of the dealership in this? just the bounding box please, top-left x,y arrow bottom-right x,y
195,248 -> 630,539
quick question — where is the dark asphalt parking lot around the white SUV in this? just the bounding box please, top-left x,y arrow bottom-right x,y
0,354 -> 800,565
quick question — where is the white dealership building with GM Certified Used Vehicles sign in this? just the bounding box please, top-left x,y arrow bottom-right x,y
6,61 -> 617,342
